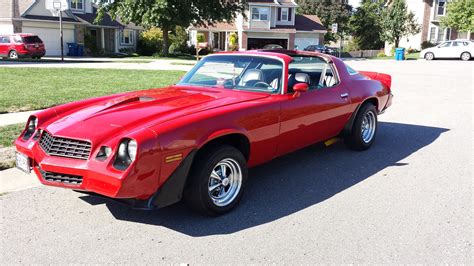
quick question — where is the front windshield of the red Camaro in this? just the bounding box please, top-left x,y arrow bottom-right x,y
178,55 -> 283,93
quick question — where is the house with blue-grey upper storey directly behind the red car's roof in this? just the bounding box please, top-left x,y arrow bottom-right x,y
188,0 -> 327,51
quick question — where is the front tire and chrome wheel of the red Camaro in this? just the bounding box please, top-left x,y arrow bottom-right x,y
184,145 -> 248,216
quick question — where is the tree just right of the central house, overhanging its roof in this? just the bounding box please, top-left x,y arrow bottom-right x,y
297,0 -> 352,43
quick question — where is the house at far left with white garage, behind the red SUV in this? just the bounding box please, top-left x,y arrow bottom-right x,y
0,0 -> 139,56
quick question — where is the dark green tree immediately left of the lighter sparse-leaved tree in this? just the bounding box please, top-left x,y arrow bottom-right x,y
350,0 -> 385,50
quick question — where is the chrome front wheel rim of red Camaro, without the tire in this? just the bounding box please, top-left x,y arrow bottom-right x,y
208,158 -> 242,207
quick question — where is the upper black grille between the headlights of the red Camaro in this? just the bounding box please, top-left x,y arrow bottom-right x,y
39,131 -> 91,160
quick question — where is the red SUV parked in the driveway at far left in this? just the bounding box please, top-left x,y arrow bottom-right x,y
0,33 -> 46,59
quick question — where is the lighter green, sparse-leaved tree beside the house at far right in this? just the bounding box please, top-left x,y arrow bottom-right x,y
382,0 -> 421,47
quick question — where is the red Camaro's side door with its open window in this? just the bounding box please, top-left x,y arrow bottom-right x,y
277,57 -> 351,155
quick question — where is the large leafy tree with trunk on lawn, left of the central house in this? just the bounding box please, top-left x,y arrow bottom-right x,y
97,0 -> 246,55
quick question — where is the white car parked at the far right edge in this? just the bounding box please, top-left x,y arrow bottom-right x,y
420,40 -> 474,61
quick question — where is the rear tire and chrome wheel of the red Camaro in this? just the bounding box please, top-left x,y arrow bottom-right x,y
344,103 -> 378,151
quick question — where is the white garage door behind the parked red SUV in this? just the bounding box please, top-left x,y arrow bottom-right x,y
23,27 -> 74,56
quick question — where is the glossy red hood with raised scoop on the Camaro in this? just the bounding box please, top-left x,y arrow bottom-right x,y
44,86 -> 269,143
